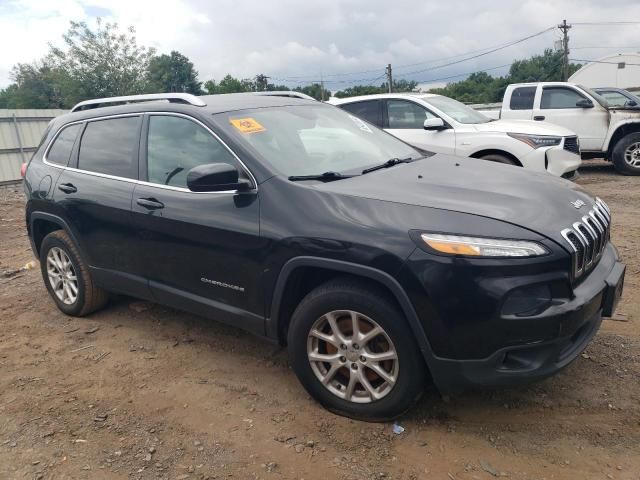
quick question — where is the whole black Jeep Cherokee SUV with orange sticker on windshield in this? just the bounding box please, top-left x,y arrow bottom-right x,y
24,94 -> 624,419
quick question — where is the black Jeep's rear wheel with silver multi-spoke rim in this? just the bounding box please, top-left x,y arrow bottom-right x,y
40,230 -> 108,317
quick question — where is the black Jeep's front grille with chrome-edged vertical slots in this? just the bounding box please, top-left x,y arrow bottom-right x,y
561,198 -> 611,279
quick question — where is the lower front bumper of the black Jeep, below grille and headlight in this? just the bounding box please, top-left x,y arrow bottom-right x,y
404,244 -> 625,394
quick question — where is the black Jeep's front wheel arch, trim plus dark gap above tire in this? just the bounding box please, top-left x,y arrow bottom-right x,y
267,257 -> 433,370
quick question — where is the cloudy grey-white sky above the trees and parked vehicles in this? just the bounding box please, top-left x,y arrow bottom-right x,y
0,0 -> 640,90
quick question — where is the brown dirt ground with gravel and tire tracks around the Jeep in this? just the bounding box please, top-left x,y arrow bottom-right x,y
0,165 -> 640,480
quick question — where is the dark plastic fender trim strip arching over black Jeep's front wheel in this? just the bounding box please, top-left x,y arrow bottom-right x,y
265,256 -> 438,375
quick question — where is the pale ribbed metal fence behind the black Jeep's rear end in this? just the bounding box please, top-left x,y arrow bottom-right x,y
0,109 -> 65,184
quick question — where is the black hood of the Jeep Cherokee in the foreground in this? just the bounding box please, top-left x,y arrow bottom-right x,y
315,154 -> 594,245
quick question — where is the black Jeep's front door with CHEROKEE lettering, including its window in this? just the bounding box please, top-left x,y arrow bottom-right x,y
132,114 -> 264,334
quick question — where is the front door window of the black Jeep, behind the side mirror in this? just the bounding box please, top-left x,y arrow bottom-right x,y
147,115 -> 238,188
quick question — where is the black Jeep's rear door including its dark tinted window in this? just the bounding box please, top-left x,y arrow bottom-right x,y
54,115 -> 149,297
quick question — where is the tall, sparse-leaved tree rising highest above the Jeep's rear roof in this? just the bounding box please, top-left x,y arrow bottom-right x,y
48,19 -> 155,100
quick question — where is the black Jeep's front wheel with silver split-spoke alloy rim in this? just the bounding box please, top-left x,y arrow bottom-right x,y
288,279 -> 426,421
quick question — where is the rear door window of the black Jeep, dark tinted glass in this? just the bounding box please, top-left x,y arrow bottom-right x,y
78,117 -> 140,178
